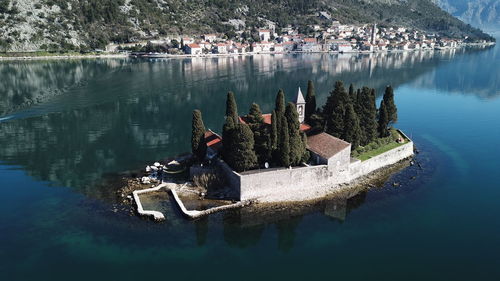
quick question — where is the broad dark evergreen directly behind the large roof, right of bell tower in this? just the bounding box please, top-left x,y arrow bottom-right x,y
323,81 -> 350,137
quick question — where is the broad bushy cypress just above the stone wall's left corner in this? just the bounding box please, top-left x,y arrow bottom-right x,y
228,124 -> 257,172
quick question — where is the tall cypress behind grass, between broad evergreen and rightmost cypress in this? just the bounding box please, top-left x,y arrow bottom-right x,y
359,87 -> 378,145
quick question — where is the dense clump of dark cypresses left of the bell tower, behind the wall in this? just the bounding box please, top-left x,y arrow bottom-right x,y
222,87 -> 309,172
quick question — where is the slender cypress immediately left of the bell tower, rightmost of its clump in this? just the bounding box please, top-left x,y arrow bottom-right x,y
285,102 -> 304,166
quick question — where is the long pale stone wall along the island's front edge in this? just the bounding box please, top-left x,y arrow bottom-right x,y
218,131 -> 413,202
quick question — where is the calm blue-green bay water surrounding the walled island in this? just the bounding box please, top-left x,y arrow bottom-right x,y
0,42 -> 500,280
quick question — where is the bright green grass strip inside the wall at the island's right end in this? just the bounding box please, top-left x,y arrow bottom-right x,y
352,129 -> 407,161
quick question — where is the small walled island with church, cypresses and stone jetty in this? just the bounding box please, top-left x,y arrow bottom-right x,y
129,81 -> 414,219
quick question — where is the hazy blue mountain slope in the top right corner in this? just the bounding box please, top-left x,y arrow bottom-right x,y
434,0 -> 500,29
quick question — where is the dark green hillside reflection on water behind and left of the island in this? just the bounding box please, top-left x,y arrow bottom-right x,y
0,48 -> 492,201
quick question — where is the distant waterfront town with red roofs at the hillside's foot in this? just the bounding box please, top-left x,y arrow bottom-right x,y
106,12 -> 492,56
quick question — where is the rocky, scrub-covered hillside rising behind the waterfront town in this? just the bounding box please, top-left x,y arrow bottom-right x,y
0,0 -> 489,52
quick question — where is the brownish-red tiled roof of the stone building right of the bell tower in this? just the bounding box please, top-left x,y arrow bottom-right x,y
307,133 -> 351,159
